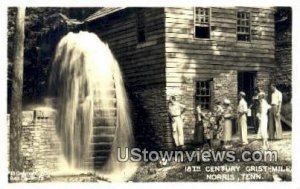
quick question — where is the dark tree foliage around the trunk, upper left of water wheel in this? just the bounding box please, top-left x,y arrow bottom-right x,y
8,7 -> 99,110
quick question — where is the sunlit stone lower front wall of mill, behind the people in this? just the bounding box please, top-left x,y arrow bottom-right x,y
166,70 -> 270,143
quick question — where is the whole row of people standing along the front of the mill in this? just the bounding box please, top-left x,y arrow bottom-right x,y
169,84 -> 282,149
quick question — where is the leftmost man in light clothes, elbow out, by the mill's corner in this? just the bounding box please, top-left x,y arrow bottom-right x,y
169,96 -> 186,147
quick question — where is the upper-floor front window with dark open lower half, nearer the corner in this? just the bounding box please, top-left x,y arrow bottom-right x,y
194,7 -> 210,39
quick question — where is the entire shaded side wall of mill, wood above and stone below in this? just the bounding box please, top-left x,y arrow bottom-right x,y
88,8 -> 173,149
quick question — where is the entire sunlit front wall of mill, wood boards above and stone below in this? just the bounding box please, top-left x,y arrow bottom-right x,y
165,7 -> 275,142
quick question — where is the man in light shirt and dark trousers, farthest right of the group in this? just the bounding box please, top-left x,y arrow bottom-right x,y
269,84 -> 282,139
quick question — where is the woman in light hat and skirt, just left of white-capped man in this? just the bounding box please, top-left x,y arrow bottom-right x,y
222,99 -> 232,148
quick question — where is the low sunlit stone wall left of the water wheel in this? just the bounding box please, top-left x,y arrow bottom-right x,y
7,109 -> 61,174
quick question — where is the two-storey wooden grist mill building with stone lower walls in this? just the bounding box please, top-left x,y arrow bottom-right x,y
82,7 -> 275,149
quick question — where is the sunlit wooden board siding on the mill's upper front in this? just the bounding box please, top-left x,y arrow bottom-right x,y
165,7 -> 275,86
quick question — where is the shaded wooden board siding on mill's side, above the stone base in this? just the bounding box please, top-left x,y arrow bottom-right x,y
88,8 -> 165,87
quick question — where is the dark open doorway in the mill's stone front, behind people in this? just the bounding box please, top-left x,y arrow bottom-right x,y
238,72 -> 257,132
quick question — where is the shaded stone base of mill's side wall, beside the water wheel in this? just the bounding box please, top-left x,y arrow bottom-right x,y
129,85 -> 174,149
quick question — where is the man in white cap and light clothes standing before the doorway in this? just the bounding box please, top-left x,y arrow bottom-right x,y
237,91 -> 248,144
